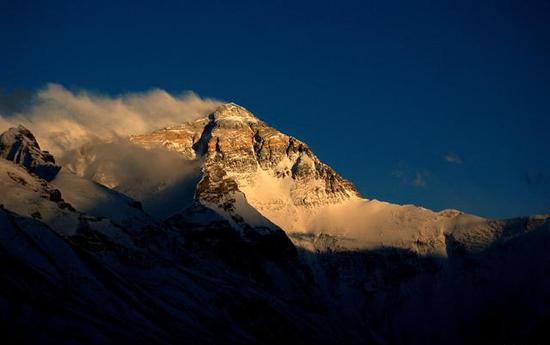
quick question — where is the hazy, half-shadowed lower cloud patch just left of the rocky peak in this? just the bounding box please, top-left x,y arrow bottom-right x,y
60,139 -> 200,220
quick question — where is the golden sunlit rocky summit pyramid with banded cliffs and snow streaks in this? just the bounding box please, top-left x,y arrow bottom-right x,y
130,103 -> 358,227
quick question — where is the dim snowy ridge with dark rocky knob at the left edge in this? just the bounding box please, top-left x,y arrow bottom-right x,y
0,126 -> 153,239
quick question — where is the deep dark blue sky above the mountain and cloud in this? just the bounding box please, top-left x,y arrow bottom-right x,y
0,0 -> 550,217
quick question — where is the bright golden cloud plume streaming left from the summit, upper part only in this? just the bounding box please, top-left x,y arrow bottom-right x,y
0,84 -> 222,156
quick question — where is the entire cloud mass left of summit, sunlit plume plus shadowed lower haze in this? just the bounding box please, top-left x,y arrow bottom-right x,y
0,84 -> 221,217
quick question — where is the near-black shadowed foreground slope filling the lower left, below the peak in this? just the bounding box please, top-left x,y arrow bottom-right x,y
0,127 -> 332,344
